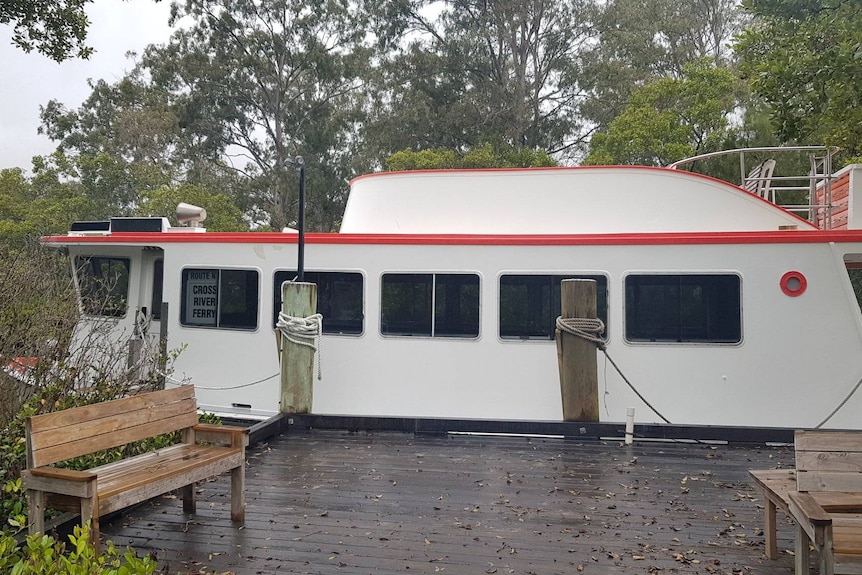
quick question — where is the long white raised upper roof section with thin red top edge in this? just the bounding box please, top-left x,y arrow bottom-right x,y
340,166 -> 816,234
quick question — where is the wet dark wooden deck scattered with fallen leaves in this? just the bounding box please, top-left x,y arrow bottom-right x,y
103,430 -> 793,575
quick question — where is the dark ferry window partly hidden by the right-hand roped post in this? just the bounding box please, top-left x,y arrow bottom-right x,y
500,274 -> 608,340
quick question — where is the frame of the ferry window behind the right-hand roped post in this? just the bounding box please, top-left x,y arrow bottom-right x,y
497,270 -> 611,343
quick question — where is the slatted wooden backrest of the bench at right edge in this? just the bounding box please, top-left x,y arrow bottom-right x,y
795,431 -> 862,492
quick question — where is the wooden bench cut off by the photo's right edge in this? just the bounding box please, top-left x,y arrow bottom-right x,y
750,431 -> 862,575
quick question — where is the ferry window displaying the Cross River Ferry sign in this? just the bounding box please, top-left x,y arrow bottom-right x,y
180,269 -> 259,329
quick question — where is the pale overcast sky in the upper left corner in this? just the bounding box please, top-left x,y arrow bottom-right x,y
0,0 -> 176,171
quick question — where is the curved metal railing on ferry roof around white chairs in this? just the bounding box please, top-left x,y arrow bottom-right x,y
667,146 -> 838,230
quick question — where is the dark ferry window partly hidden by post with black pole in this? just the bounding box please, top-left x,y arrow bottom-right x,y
272,271 -> 364,335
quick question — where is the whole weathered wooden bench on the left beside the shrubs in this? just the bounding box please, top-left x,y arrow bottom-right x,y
21,385 -> 248,547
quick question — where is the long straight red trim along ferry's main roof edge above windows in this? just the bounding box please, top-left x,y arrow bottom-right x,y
42,230 -> 862,246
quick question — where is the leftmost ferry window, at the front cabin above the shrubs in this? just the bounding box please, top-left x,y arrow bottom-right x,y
75,256 -> 131,317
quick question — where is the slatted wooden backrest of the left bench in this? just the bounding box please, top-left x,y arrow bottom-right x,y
26,385 -> 198,468
